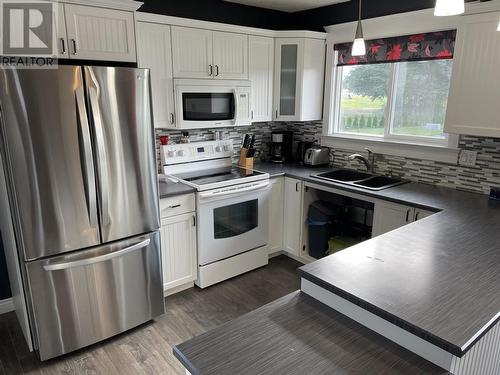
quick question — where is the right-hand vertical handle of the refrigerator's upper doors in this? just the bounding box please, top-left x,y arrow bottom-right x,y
88,87 -> 110,225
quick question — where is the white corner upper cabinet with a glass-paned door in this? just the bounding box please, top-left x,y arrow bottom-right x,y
274,38 -> 325,121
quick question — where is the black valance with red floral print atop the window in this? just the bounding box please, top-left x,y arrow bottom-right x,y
335,30 -> 457,66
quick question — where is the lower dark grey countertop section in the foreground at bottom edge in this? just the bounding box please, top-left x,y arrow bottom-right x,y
174,291 -> 448,375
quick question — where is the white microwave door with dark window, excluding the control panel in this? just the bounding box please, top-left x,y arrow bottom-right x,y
175,85 -> 238,129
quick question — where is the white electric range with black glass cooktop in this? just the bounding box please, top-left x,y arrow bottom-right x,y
161,140 -> 270,288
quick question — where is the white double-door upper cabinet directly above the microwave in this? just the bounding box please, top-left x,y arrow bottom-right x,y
172,26 -> 248,79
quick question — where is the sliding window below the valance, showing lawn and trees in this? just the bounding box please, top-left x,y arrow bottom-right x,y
334,59 -> 453,144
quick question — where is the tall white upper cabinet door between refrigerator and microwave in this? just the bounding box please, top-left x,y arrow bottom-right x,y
137,22 -> 175,128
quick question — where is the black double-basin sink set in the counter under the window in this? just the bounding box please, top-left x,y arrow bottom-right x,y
312,169 -> 408,190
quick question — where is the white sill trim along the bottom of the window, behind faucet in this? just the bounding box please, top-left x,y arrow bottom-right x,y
321,135 -> 460,165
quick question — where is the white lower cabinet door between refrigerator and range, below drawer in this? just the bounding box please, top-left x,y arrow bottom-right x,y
160,212 -> 196,290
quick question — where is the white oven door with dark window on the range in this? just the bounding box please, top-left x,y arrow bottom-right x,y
197,180 -> 270,266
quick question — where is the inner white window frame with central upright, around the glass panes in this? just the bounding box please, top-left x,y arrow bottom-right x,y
334,61 -> 457,148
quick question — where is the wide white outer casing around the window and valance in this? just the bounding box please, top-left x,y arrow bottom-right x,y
321,9 -> 480,165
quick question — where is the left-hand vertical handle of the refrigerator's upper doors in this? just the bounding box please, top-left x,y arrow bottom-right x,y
75,86 -> 97,228
